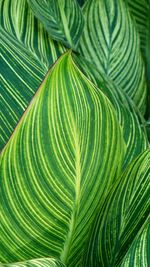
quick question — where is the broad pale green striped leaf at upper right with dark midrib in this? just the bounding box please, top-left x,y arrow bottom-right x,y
79,0 -> 146,113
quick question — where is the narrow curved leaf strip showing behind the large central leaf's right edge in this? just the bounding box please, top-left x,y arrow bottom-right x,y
74,55 -> 149,167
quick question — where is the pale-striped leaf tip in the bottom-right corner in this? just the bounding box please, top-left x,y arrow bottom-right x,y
121,222 -> 150,267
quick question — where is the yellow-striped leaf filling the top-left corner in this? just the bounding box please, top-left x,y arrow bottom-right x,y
0,0 -> 64,71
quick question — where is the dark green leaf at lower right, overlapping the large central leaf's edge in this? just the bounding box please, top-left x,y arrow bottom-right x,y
84,149 -> 150,267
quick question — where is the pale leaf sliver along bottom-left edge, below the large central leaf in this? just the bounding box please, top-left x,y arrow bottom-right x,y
0,258 -> 65,267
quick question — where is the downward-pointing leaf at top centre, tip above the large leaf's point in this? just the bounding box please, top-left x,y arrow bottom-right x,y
28,0 -> 84,48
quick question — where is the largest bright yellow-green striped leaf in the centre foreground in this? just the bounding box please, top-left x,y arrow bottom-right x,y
0,53 -> 124,266
